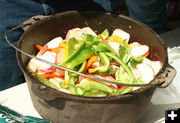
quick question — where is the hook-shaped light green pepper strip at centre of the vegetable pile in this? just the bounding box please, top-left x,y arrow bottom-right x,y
96,52 -> 110,72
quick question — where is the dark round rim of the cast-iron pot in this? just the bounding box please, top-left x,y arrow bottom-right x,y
16,11 -> 168,101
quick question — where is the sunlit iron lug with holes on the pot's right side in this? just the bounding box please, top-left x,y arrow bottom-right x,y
157,64 -> 176,88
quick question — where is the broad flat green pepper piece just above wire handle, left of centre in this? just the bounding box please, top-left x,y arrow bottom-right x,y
69,47 -> 94,70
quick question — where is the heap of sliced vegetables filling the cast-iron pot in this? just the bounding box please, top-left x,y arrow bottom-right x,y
27,27 -> 162,97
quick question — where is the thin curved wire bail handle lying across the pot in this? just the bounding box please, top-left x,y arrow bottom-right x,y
5,23 -> 159,87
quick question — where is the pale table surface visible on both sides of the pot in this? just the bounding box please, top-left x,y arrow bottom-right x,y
0,28 -> 180,123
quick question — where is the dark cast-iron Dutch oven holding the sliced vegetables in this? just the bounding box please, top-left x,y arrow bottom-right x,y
17,11 -> 175,123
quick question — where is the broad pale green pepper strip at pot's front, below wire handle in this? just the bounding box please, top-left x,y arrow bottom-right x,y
78,81 -> 113,93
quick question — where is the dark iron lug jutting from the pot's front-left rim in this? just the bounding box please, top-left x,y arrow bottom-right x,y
31,80 -> 61,101
